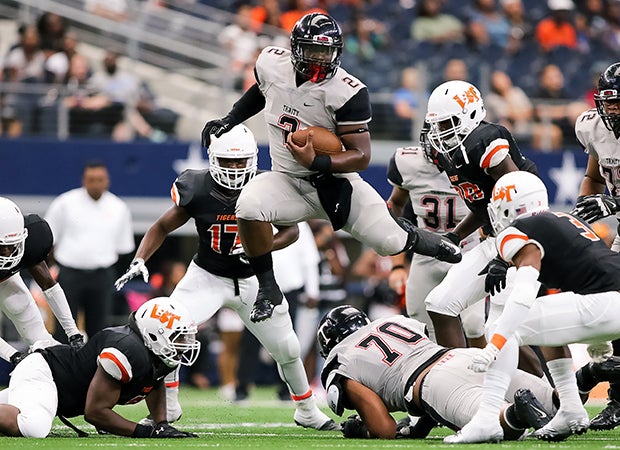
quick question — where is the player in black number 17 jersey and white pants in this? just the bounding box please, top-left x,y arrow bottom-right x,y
116,125 -> 339,430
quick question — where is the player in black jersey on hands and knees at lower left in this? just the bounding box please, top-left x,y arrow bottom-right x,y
0,297 -> 200,438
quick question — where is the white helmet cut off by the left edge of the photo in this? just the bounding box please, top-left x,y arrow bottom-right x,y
0,197 -> 28,270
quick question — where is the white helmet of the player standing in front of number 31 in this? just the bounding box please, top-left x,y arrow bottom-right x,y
425,80 -> 487,153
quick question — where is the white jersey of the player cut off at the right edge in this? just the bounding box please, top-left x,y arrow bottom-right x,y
575,109 -> 620,209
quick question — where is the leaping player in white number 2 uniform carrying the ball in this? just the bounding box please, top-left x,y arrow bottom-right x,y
202,13 -> 461,322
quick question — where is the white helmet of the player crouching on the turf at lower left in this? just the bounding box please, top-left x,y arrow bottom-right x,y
134,297 -> 200,367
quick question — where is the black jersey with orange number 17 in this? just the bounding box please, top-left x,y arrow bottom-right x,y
171,169 -> 253,278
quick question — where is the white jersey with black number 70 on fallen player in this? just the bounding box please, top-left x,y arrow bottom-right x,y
321,316 -> 448,412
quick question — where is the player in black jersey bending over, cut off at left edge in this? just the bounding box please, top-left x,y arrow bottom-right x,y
0,197 -> 84,364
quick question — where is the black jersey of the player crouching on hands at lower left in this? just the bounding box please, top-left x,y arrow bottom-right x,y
38,325 -> 174,417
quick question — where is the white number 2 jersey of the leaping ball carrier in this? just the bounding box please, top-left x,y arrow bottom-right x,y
255,46 -> 371,176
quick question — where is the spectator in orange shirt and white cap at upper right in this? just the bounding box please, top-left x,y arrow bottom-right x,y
536,0 -> 577,51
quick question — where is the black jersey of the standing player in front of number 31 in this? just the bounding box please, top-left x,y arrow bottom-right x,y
434,121 -> 538,234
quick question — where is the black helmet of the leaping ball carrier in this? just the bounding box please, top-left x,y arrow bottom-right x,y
291,13 -> 344,83
